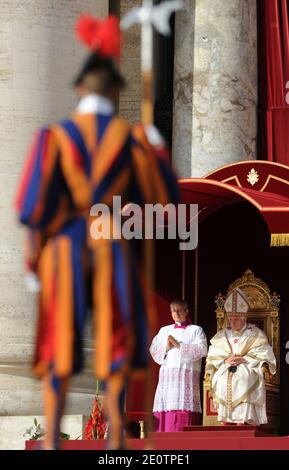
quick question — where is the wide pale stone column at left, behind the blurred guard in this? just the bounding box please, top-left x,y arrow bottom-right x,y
0,0 -> 108,416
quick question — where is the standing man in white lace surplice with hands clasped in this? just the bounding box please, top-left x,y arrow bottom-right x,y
150,300 -> 207,432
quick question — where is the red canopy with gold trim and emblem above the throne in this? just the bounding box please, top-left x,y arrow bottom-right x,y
179,160 -> 289,246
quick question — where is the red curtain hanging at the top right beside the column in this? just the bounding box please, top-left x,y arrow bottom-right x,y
257,0 -> 289,165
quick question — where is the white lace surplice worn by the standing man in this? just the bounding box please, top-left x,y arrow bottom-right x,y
150,325 -> 207,412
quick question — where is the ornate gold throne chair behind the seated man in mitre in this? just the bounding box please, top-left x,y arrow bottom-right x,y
203,269 -> 280,434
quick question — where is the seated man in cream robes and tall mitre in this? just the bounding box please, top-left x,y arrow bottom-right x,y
206,289 -> 276,425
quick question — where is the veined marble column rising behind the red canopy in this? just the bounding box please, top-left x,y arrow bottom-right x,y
173,0 -> 257,177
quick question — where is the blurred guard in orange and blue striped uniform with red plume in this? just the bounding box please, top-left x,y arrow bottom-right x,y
16,12 -> 177,449
